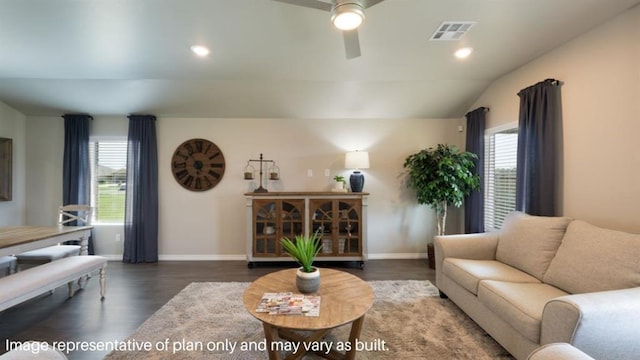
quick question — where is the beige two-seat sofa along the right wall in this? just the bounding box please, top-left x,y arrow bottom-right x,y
435,212 -> 640,359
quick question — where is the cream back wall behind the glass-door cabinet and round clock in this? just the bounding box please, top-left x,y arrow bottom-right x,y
27,116 -> 463,259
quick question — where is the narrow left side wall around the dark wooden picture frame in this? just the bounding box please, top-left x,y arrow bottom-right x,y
0,102 -> 26,226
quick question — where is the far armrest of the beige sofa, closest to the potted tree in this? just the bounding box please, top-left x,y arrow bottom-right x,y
433,232 -> 499,283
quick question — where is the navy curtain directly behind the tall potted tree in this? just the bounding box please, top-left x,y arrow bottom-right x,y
464,107 -> 489,234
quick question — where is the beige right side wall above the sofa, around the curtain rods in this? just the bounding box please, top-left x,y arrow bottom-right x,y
473,7 -> 640,233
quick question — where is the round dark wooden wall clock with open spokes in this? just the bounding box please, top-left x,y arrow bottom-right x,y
171,139 -> 225,191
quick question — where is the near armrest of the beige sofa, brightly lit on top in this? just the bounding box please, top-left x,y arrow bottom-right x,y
540,287 -> 640,359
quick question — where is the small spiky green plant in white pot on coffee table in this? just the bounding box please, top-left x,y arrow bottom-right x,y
280,231 -> 322,293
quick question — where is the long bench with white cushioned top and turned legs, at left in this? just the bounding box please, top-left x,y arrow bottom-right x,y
0,255 -> 107,311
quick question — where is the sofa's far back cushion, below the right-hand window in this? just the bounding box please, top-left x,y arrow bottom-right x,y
496,212 -> 571,281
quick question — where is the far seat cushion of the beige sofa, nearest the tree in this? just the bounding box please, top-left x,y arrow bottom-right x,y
442,258 -> 540,295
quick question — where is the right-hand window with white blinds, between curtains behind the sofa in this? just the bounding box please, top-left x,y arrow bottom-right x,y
484,125 -> 518,231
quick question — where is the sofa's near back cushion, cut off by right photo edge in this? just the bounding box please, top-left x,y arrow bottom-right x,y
544,220 -> 640,294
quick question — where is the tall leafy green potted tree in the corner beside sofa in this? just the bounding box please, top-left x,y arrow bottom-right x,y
404,144 -> 480,268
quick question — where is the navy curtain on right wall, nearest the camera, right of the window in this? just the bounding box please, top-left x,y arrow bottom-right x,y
516,79 -> 561,216
